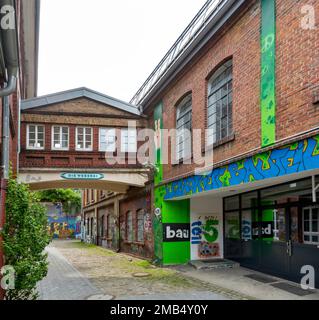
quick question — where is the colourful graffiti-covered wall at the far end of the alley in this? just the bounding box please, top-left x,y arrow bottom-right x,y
44,203 -> 81,239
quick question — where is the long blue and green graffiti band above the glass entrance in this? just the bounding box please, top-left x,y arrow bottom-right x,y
165,136 -> 319,200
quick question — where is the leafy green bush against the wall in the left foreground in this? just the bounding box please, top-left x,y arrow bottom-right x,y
2,178 -> 50,300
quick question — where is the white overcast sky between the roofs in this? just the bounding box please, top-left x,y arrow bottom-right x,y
38,0 -> 205,101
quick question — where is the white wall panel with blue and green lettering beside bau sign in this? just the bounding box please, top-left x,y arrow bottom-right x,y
191,213 -> 223,260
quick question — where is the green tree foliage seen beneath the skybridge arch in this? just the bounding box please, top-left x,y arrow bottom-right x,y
37,189 -> 81,214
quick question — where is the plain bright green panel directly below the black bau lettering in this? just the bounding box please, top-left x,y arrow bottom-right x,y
163,242 -> 191,265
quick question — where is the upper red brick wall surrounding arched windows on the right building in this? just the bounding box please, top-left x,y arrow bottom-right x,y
147,0 -> 319,184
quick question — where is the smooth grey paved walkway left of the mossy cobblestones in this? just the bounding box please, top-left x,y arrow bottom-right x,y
38,246 -> 101,300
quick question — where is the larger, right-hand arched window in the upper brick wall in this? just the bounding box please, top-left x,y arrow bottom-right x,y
207,60 -> 233,145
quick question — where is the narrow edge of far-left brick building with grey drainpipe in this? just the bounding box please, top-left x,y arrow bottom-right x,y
0,0 -> 40,300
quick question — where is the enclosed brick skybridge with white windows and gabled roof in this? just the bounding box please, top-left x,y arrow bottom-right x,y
18,88 -> 148,193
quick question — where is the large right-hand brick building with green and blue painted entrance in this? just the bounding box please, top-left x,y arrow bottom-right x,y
131,0 -> 319,286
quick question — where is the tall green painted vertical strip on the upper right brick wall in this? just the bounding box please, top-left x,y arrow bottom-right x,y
260,0 -> 276,147
